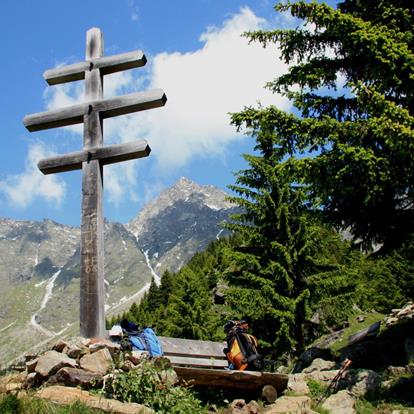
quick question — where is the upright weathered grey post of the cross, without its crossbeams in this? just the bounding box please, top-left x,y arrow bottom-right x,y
80,28 -> 105,338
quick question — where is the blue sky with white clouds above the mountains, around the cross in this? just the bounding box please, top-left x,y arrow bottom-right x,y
0,0 -> 336,226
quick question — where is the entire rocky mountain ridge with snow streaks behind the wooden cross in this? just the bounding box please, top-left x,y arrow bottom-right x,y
0,178 -> 234,363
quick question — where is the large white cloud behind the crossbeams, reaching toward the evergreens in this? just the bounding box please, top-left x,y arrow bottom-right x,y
42,7 -> 290,202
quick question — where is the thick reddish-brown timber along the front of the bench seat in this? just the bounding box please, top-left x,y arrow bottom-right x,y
174,367 -> 288,395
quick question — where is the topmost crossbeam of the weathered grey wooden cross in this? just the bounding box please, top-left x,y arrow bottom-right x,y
43,50 -> 147,85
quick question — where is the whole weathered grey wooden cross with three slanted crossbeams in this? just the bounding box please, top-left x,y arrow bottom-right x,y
23,28 -> 167,338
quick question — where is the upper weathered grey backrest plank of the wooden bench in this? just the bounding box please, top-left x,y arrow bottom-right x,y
159,336 -> 227,359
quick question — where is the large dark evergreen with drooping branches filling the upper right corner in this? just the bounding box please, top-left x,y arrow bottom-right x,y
232,0 -> 414,251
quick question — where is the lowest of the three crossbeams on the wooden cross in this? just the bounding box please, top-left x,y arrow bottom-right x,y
37,140 -> 151,175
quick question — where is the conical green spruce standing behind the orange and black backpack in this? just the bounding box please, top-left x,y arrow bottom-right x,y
226,118 -> 312,351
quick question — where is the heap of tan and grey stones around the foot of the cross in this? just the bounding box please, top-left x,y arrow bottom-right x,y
0,338 -> 162,414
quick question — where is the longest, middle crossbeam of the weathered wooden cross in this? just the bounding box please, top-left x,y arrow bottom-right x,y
23,89 -> 167,132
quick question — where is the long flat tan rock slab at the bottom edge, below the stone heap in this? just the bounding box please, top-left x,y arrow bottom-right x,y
36,385 -> 155,414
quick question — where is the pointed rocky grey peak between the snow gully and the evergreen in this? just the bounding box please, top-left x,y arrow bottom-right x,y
127,178 -> 236,274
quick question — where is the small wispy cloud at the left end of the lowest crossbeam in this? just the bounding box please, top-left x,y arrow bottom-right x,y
0,143 -> 66,208
